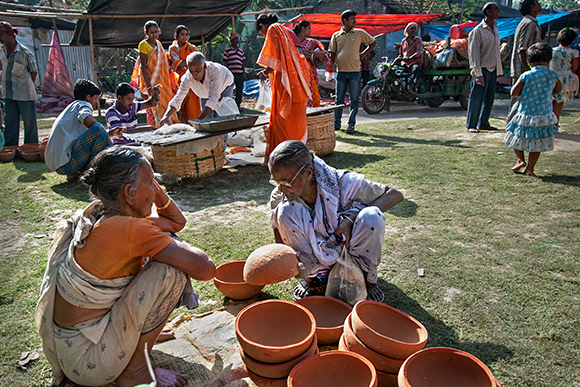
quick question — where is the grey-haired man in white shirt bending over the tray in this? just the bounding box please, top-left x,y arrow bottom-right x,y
161,52 -> 239,125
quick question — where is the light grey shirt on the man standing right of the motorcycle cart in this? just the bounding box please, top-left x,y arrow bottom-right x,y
469,21 -> 503,77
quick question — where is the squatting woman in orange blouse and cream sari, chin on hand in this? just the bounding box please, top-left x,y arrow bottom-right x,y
36,147 -> 216,387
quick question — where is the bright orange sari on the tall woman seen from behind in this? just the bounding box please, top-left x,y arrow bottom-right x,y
258,23 -> 311,162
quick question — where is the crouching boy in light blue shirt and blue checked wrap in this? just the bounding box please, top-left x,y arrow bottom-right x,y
44,79 -> 115,181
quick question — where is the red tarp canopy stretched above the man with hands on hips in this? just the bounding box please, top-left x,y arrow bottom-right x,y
286,13 -> 444,38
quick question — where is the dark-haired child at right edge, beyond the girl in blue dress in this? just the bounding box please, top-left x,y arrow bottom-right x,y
550,27 -> 579,121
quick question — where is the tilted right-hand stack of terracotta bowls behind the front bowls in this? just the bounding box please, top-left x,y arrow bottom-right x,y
338,301 -> 428,387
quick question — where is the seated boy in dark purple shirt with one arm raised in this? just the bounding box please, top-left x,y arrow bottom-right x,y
105,82 -> 159,144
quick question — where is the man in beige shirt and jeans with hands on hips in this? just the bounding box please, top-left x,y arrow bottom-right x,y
328,9 -> 377,134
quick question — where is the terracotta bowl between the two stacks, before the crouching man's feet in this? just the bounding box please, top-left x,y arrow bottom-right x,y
296,296 -> 352,345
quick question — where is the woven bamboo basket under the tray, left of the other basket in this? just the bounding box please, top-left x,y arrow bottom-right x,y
151,141 -> 225,178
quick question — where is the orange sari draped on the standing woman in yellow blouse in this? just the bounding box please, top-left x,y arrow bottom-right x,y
131,41 -> 179,128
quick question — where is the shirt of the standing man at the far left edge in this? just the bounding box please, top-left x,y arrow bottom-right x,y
0,42 -> 38,101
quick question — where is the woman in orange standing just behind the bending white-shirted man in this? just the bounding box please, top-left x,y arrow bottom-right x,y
168,25 -> 201,124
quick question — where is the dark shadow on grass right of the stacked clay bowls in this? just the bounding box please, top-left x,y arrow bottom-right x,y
378,278 -> 513,365
